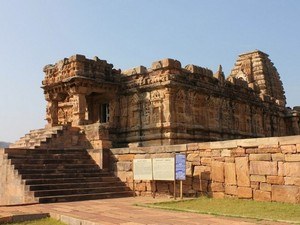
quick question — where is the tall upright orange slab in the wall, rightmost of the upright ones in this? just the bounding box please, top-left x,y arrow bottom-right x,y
235,157 -> 250,187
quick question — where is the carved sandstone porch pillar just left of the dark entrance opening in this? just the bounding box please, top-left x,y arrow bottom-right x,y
72,93 -> 87,126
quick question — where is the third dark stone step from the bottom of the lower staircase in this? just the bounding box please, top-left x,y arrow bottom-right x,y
29,181 -> 126,191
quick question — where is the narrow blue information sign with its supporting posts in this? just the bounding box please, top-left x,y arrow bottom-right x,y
174,154 -> 186,199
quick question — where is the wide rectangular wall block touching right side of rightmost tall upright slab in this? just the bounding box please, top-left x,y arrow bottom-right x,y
250,161 -> 277,175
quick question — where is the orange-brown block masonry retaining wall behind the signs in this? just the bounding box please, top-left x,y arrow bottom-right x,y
110,136 -> 300,203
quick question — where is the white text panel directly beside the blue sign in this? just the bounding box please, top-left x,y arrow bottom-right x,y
153,158 -> 175,180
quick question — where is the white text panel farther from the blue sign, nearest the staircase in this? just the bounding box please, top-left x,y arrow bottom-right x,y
133,159 -> 152,180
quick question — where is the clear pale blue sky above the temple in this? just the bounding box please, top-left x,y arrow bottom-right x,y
0,0 -> 300,141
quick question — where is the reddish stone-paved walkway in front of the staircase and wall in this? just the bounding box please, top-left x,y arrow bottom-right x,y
0,197 -> 292,225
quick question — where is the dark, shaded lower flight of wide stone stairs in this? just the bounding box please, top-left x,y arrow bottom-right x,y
4,149 -> 132,203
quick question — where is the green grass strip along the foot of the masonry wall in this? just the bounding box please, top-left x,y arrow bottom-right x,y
149,197 -> 300,224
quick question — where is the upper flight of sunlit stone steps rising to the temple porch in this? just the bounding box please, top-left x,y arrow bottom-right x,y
9,126 -> 88,149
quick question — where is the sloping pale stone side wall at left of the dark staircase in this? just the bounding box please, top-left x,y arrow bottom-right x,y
0,149 -> 38,205
